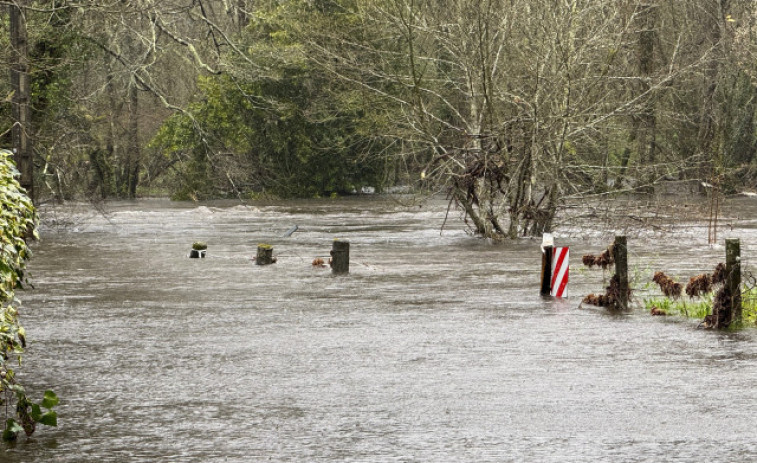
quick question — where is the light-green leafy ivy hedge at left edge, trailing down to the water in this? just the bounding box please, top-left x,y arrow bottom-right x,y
0,150 -> 58,441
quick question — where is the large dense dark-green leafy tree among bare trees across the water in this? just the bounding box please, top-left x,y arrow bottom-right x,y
151,2 -> 392,199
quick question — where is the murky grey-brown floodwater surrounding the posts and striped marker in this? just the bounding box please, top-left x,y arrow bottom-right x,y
0,198 -> 757,463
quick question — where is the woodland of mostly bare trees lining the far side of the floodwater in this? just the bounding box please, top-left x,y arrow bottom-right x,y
0,0 -> 757,237
